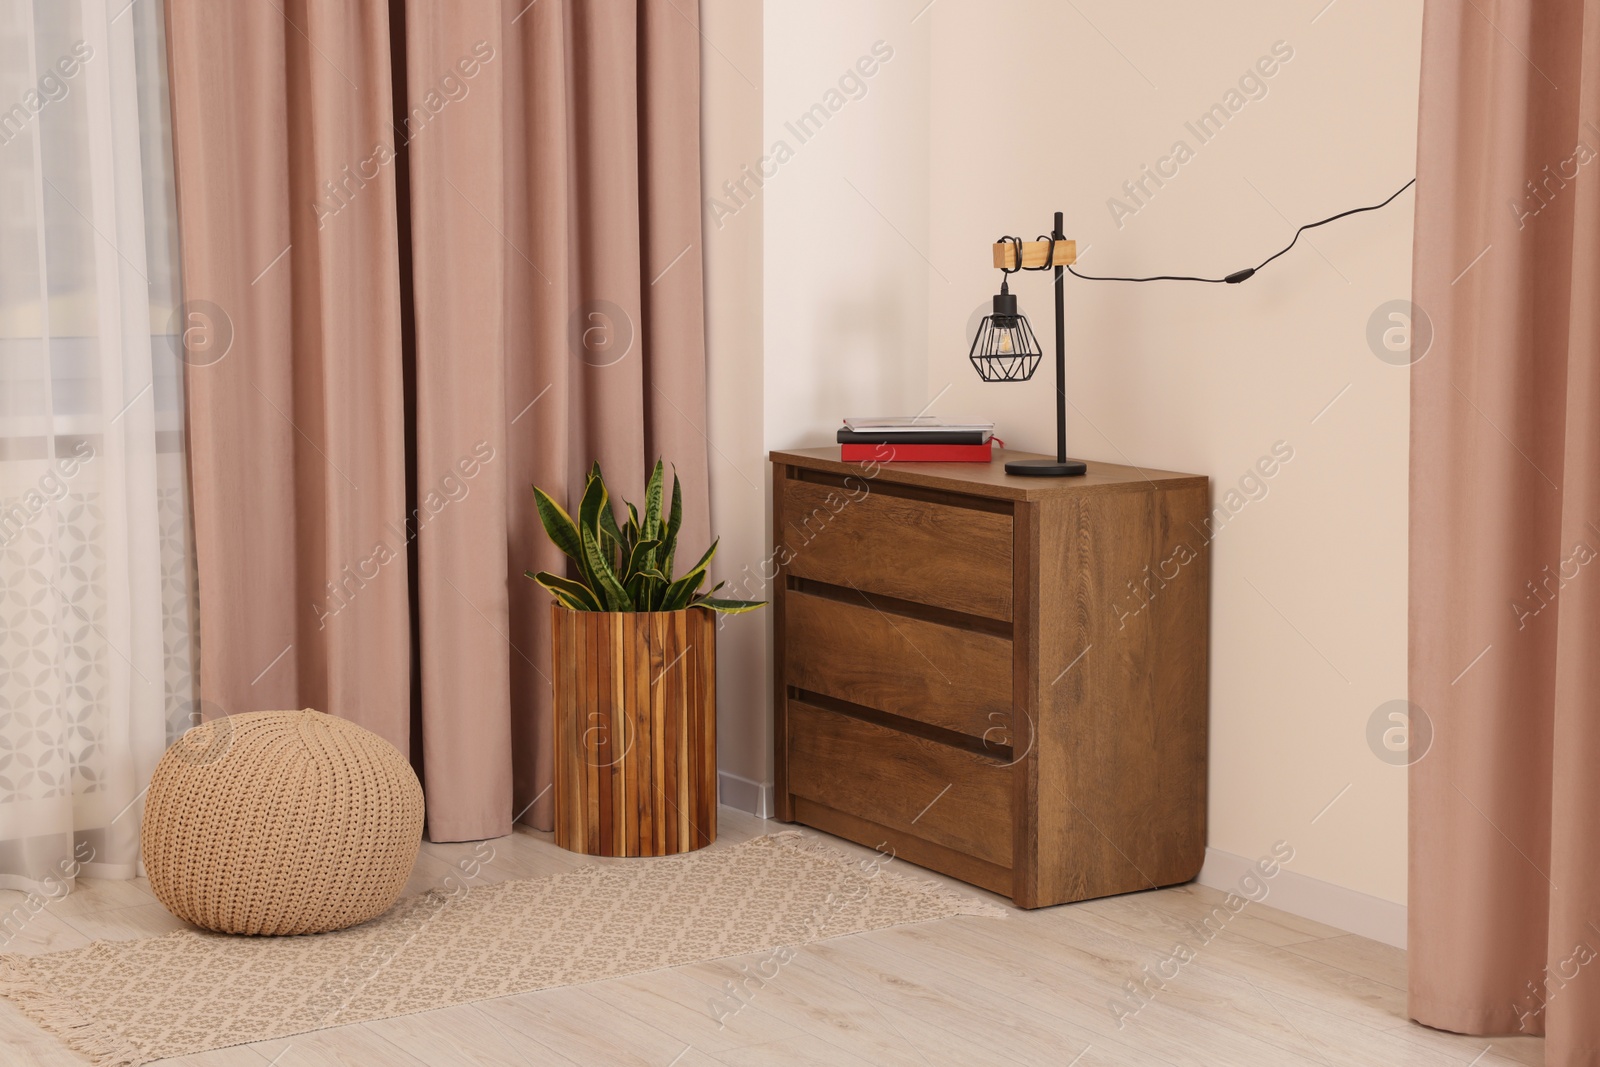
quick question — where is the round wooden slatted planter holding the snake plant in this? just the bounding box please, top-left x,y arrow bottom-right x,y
550,605 -> 717,856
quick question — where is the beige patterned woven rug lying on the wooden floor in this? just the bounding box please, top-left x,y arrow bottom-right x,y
0,830 -> 1005,1067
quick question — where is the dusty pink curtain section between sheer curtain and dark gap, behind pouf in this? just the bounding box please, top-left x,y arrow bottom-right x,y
168,0 -> 410,752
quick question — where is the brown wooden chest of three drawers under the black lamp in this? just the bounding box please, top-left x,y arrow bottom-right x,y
771,448 -> 1210,907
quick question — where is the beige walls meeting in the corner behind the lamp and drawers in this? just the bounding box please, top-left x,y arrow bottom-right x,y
706,0 -> 1421,901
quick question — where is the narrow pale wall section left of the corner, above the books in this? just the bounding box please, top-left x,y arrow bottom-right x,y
762,0 -> 933,448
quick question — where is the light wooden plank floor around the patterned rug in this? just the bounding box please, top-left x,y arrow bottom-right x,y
0,808 -> 1544,1067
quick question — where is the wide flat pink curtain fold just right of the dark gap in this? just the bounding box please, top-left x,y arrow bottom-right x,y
405,0 -> 512,841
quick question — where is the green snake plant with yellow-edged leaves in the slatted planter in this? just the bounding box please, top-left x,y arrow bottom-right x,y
526,461 -> 765,614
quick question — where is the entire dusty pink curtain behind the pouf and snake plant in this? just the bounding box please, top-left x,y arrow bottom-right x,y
168,0 -> 709,840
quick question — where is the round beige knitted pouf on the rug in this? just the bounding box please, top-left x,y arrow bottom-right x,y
141,709 -> 422,934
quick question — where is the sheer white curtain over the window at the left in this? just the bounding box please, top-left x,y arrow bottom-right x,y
0,0 -> 198,894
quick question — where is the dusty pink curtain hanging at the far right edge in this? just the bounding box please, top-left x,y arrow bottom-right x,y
1408,0 -> 1600,1065
